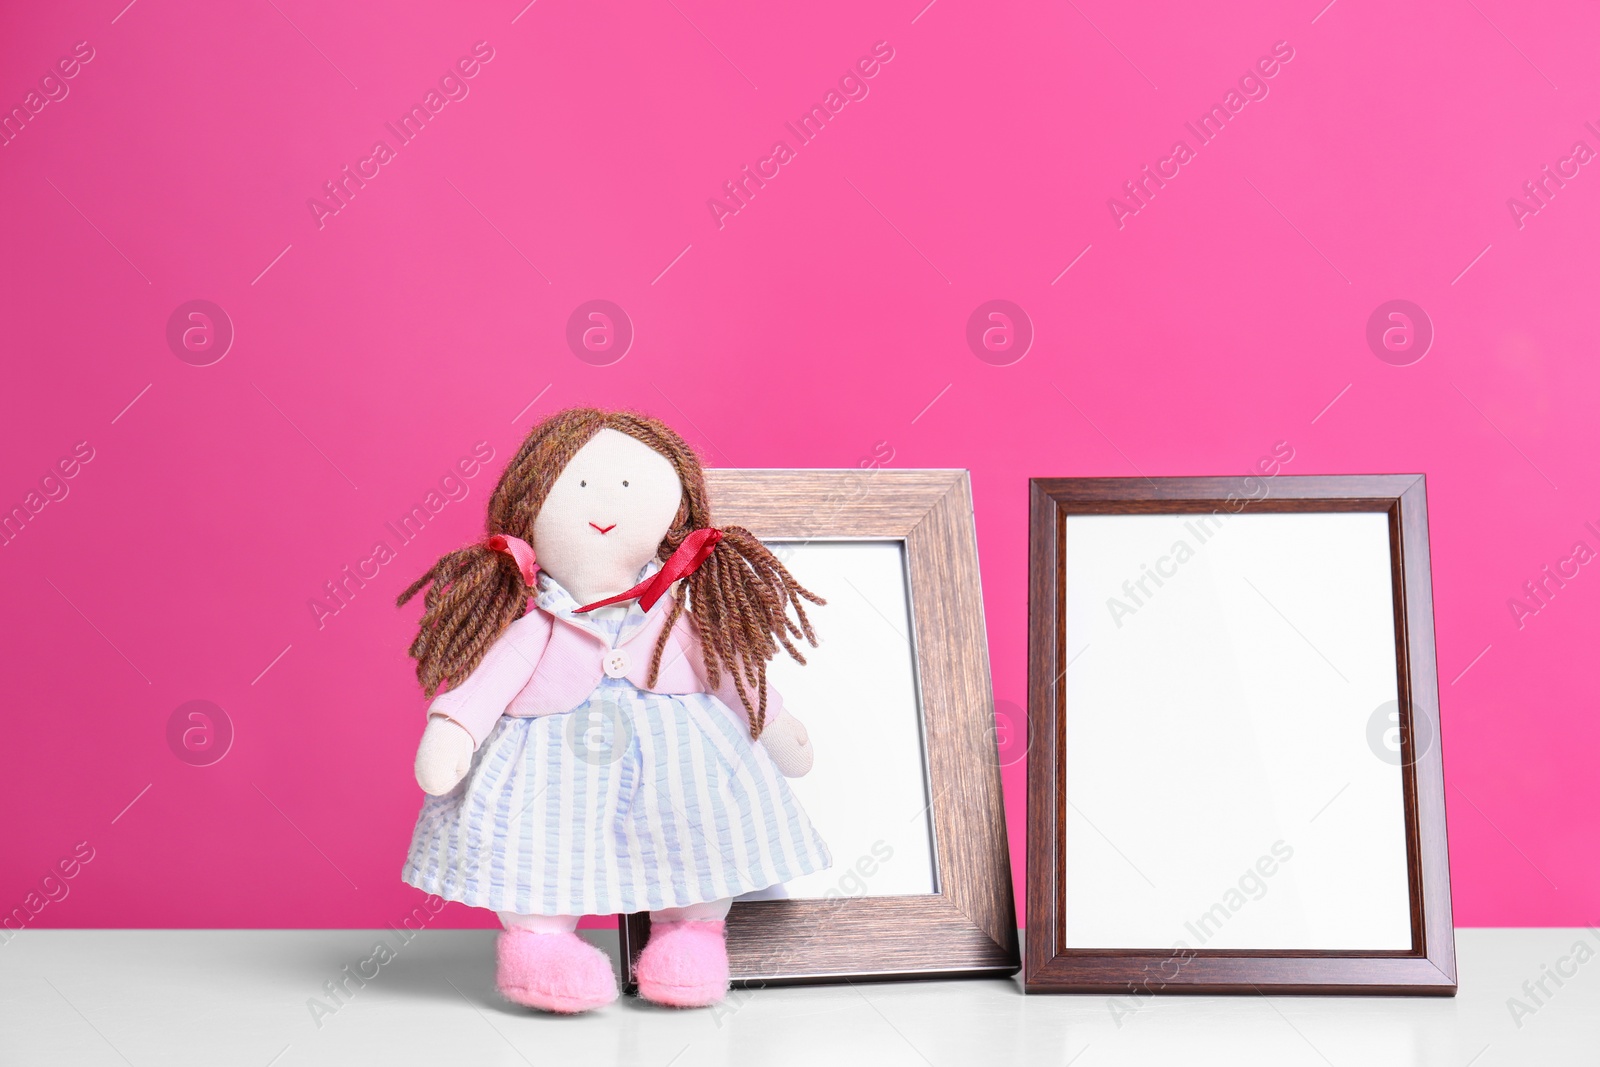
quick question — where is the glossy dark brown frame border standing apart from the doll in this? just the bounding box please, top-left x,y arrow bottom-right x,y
1024,475 -> 1456,995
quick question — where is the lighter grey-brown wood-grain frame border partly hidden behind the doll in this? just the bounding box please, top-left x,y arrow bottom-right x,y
618,469 -> 1021,990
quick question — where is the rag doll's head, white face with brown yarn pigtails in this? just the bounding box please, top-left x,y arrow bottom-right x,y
398,408 -> 822,736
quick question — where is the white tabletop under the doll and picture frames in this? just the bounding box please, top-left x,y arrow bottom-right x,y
0,929 -> 1600,1067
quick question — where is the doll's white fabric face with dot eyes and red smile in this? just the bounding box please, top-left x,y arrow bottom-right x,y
533,429 -> 683,603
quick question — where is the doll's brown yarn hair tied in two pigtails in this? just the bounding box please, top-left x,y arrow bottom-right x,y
397,408 -> 824,737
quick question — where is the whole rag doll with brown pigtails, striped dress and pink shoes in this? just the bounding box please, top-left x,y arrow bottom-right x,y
400,410 -> 830,1013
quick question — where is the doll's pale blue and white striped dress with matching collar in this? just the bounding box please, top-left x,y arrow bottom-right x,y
402,573 -> 832,915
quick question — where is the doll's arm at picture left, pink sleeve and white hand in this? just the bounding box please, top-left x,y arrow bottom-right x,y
416,613 -> 550,795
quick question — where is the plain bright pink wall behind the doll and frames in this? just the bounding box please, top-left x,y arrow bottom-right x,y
0,0 -> 1600,926
